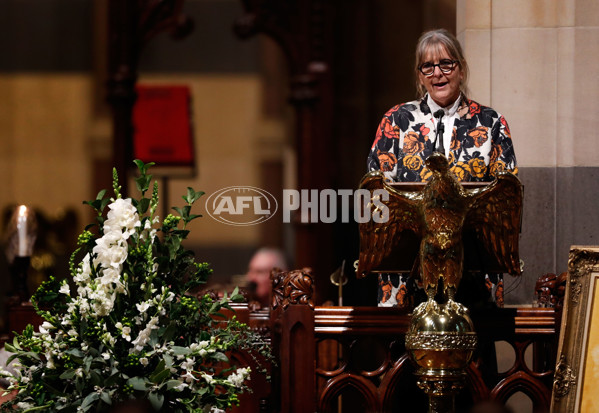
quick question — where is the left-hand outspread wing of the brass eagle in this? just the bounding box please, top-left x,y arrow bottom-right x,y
356,171 -> 422,278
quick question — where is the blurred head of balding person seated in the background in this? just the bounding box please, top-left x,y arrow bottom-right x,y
245,247 -> 288,308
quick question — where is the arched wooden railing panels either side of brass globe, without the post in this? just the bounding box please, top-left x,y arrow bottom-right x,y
314,307 -> 557,412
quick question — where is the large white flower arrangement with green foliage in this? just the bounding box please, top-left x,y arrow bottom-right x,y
0,161 -> 268,412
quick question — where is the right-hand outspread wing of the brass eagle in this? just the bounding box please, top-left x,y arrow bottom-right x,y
466,172 -> 523,276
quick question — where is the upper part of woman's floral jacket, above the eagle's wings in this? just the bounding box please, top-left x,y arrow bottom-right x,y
368,95 -> 518,182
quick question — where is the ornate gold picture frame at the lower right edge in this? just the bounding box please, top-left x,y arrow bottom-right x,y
551,246 -> 599,413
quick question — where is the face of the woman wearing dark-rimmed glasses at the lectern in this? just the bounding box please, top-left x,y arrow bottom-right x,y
418,45 -> 463,108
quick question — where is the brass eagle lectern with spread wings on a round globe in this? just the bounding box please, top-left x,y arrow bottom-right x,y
357,153 -> 523,412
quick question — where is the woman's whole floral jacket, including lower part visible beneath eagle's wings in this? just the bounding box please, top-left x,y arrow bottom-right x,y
368,95 -> 518,309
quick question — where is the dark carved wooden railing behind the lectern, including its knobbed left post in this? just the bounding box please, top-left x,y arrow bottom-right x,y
271,271 -> 559,413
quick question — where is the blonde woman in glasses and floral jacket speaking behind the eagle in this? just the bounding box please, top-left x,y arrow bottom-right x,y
368,29 -> 518,306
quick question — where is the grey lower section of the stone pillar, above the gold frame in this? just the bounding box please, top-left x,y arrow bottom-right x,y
505,167 -> 599,304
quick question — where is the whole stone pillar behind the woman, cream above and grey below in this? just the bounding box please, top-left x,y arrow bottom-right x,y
456,0 -> 599,304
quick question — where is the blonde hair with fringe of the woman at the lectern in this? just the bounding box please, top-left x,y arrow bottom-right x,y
414,29 -> 468,97
